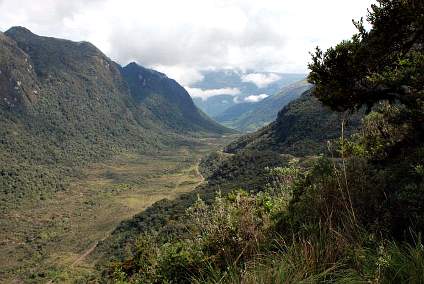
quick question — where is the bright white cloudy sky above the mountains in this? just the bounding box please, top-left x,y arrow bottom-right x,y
0,0 -> 374,95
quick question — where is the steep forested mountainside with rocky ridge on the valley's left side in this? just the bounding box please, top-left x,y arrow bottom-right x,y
0,27 -> 228,207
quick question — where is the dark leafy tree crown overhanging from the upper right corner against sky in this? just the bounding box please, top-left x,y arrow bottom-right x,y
308,0 -> 424,112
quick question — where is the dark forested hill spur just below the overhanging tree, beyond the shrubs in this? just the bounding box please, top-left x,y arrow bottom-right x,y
225,89 -> 364,156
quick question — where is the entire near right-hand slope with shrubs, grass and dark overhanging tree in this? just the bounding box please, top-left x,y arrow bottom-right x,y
93,0 -> 424,283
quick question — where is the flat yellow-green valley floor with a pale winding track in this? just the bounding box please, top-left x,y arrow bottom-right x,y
0,138 -> 229,283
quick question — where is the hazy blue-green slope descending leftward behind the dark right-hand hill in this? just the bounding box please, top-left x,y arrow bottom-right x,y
215,81 -> 311,132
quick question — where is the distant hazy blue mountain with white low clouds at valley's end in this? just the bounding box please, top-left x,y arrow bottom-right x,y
190,69 -> 306,118
